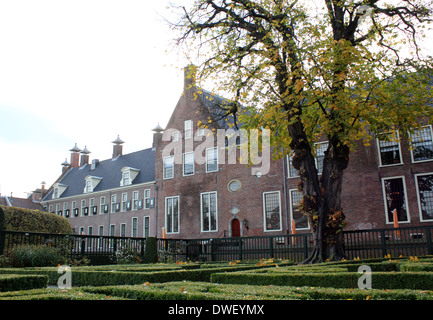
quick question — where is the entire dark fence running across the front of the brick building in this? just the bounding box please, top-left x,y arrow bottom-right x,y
0,226 -> 433,264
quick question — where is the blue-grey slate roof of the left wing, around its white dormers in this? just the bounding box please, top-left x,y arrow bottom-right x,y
43,148 -> 155,201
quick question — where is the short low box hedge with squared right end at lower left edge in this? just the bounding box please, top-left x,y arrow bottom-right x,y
0,274 -> 48,292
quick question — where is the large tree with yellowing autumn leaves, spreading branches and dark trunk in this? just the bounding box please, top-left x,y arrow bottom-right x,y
169,0 -> 433,261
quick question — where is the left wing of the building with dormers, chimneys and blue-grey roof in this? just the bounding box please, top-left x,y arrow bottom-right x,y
43,137 -> 156,237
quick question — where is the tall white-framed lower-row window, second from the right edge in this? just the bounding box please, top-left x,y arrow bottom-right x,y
382,177 -> 409,223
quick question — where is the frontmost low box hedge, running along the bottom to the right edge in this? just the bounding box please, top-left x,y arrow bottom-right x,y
82,281 -> 433,301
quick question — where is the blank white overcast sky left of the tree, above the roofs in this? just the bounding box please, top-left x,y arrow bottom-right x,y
0,0 -> 431,197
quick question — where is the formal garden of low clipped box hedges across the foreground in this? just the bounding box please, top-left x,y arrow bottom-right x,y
0,256 -> 433,300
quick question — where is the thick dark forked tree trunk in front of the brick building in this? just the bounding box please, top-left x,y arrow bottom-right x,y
292,129 -> 349,263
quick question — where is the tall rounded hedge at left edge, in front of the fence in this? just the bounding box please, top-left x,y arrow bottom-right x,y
1,206 -> 72,234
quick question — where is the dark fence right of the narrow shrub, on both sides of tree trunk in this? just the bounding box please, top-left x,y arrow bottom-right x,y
158,226 -> 433,262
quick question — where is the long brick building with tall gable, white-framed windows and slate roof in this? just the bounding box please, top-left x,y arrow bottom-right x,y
43,66 -> 433,239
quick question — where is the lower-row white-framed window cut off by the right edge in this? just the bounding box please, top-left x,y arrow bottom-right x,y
415,173 -> 433,221
